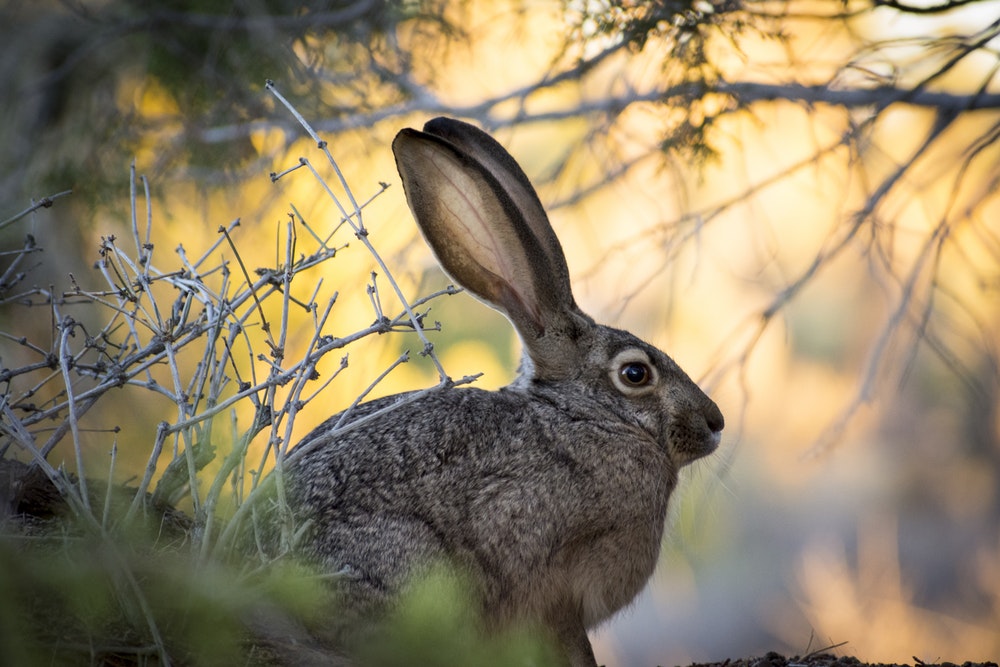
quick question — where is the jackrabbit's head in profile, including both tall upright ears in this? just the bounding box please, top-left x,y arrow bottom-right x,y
393,118 -> 724,466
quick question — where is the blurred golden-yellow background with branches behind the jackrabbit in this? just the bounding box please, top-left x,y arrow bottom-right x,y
0,0 -> 1000,666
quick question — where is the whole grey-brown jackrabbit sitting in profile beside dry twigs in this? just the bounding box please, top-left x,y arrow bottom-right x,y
278,118 -> 724,665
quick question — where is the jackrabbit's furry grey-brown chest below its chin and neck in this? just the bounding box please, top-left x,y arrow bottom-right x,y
512,394 -> 676,627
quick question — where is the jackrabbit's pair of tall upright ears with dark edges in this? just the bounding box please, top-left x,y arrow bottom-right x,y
392,118 -> 592,379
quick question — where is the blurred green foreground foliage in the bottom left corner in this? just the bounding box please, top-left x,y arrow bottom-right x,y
0,523 -> 325,667
